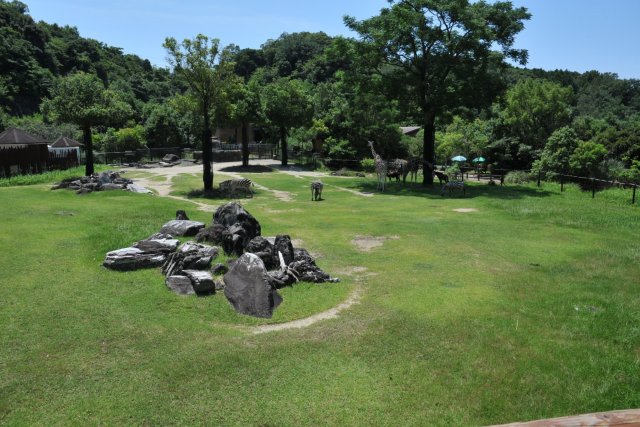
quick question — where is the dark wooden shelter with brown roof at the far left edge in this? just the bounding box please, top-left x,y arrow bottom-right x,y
0,128 -> 49,177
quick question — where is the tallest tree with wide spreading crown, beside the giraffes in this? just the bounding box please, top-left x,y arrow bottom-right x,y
344,0 -> 530,185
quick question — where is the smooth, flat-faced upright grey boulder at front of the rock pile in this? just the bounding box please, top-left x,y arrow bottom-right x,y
224,253 -> 282,318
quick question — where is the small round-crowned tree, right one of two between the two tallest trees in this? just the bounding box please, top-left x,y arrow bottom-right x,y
260,79 -> 313,166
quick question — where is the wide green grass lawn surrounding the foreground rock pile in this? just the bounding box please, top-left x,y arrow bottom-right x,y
0,172 -> 640,426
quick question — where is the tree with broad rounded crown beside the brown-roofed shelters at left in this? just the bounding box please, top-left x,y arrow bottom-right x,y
42,72 -> 133,176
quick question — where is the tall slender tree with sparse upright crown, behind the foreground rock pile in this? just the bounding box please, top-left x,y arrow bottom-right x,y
163,34 -> 221,191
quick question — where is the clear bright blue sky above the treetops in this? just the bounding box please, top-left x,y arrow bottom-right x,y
22,0 -> 640,78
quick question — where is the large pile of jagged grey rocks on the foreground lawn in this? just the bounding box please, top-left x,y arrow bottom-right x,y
103,206 -> 338,318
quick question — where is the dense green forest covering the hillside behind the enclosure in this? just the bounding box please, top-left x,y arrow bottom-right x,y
0,0 -> 640,182
